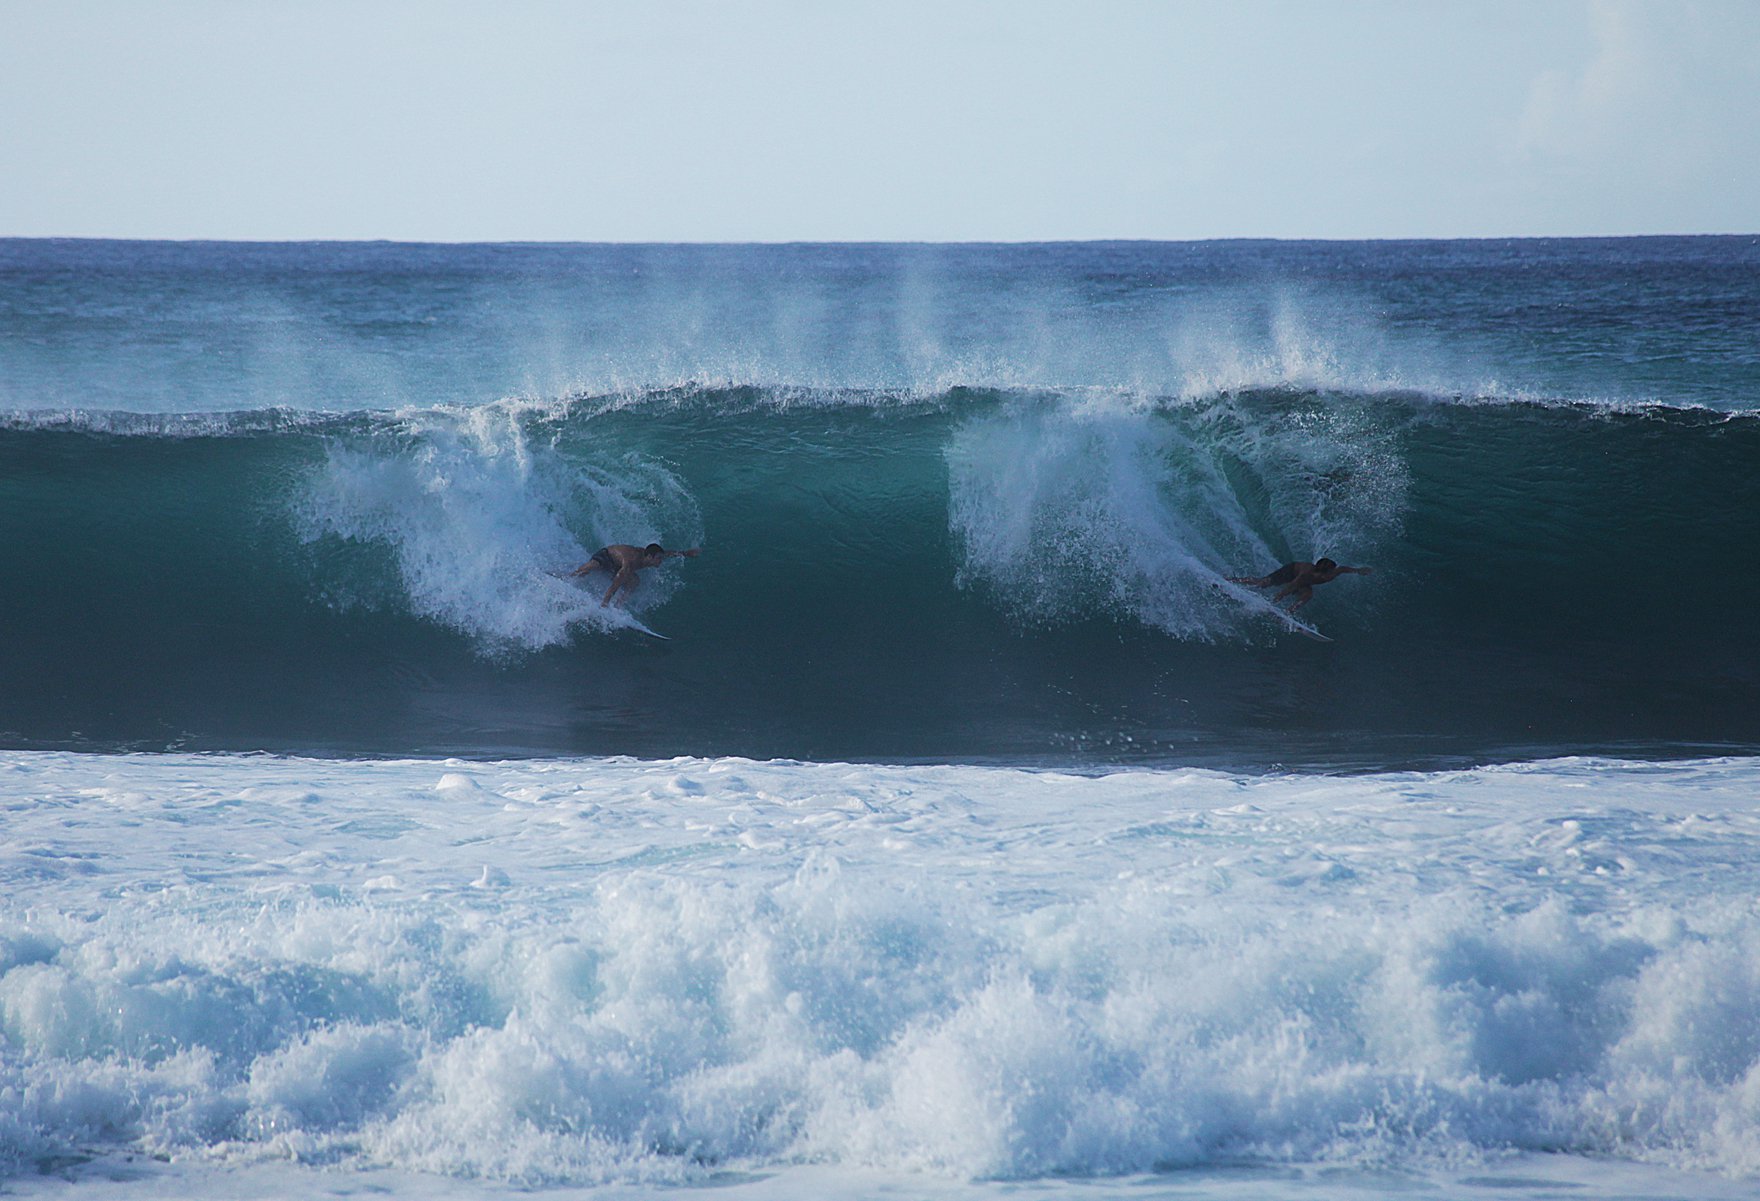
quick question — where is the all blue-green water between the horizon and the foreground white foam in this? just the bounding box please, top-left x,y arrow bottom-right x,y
0,238 -> 1760,766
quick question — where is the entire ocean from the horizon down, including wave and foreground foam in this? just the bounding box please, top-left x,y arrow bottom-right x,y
0,236 -> 1760,1201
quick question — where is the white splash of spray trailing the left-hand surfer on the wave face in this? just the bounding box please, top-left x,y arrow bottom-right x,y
296,405 -> 700,655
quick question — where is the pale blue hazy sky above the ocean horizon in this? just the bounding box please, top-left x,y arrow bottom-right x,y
0,0 -> 1760,241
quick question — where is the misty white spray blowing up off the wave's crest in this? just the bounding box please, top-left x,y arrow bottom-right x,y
488,247 -> 1477,396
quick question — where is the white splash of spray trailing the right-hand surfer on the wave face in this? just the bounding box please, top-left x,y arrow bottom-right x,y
947,393 -> 1406,641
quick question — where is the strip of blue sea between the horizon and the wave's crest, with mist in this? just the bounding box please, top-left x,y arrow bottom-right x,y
0,238 -> 1760,414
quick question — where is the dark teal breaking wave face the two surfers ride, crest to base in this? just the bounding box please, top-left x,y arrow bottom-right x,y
0,387 -> 1760,759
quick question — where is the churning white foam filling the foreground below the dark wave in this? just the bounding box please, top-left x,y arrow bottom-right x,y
0,752 -> 1760,1185
